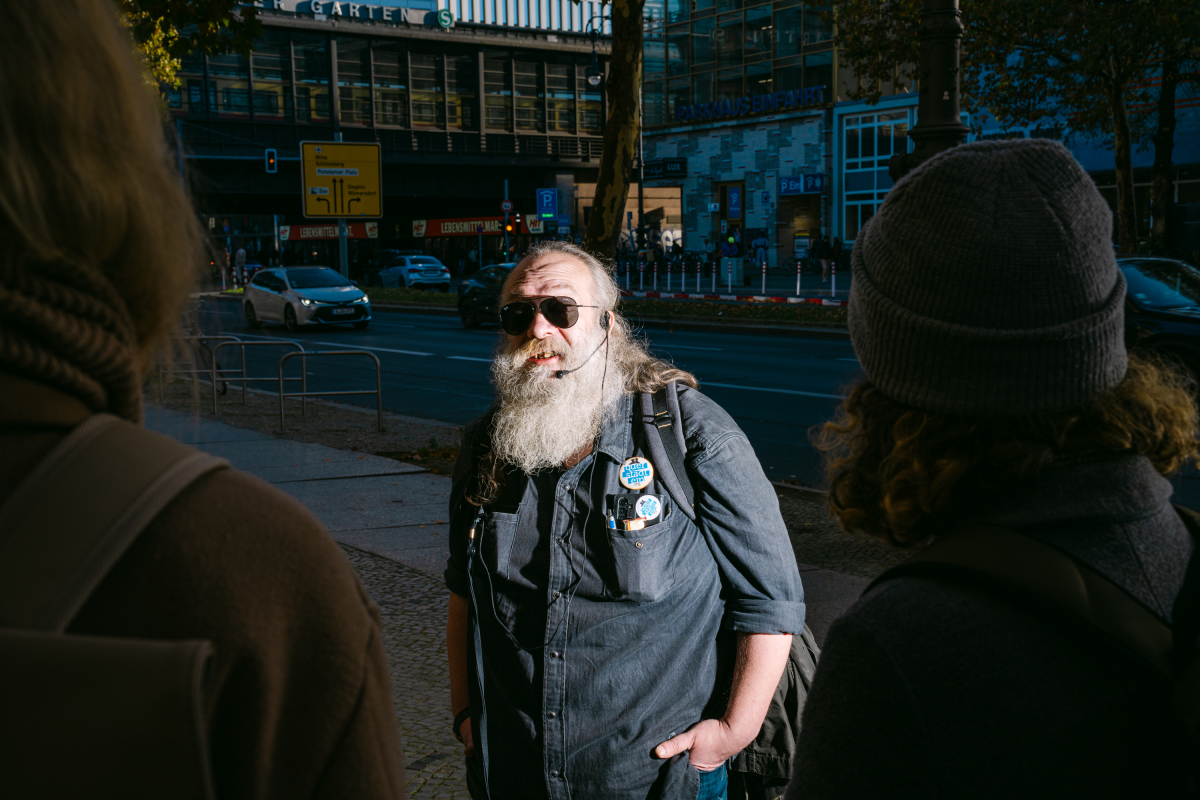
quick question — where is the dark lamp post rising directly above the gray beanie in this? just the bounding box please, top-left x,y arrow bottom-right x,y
888,0 -> 970,181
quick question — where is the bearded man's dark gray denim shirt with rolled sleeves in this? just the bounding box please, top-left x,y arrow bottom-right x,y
445,389 -> 804,800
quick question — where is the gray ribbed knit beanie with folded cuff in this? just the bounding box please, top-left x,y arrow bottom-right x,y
850,139 -> 1126,416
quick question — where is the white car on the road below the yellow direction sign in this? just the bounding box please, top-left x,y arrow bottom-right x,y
241,266 -> 371,331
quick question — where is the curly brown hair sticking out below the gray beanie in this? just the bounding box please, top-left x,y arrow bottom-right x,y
814,354 -> 1200,546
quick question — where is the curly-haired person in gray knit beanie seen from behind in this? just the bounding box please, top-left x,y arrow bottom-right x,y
787,140 -> 1196,799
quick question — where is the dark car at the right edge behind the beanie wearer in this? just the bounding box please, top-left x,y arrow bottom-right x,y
1117,255 -> 1200,375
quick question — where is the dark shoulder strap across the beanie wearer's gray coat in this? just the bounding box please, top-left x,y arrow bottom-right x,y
866,525 -> 1172,678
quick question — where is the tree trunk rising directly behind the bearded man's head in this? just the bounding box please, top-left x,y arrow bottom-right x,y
583,0 -> 646,258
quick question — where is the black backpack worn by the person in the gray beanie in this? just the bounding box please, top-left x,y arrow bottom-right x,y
864,506 -> 1200,798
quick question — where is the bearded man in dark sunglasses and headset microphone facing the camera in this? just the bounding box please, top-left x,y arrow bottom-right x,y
445,242 -> 804,800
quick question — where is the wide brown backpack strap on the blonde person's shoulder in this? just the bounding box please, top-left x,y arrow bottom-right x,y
0,414 -> 229,633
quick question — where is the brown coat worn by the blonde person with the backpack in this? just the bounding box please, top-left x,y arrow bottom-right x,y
0,372 -> 404,800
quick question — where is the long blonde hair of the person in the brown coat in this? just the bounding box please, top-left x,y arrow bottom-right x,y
0,0 -> 200,368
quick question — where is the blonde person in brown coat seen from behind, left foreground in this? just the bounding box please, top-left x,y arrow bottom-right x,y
0,0 -> 404,800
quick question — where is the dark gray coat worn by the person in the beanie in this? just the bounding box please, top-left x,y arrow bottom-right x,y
787,455 -> 1192,798
